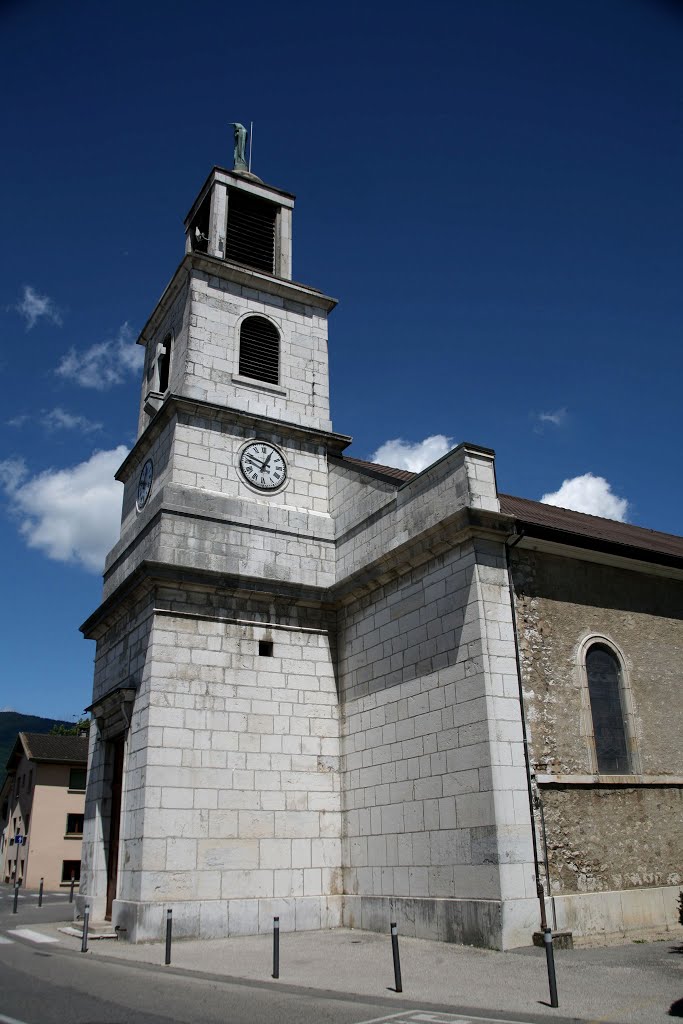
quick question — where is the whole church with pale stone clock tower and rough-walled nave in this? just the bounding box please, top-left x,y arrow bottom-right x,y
79,140 -> 683,949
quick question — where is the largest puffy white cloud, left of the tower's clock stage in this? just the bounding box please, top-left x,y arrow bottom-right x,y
0,444 -> 128,572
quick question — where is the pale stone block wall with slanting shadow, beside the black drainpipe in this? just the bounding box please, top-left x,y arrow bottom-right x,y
338,541 -> 536,946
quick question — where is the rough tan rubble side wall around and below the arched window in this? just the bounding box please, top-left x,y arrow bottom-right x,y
511,548 -> 683,894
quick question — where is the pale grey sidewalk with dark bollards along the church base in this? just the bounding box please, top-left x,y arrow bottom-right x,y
45,925 -> 683,1024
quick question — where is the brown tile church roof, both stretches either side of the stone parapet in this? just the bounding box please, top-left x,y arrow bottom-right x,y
337,456 -> 683,564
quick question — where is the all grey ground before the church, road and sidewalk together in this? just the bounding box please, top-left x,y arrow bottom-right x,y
0,889 -> 683,1024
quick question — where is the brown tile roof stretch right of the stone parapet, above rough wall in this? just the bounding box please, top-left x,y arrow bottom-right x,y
499,495 -> 683,561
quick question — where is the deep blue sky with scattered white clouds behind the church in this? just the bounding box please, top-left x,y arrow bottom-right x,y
0,0 -> 683,718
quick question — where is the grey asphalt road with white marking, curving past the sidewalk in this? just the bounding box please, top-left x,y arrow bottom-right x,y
0,888 -> 581,1024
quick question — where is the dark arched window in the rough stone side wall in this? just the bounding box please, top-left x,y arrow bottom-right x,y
586,643 -> 631,775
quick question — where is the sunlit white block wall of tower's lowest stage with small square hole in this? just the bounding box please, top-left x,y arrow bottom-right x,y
109,589 -> 342,940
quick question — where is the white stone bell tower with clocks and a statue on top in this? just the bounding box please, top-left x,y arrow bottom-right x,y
80,132 -> 349,941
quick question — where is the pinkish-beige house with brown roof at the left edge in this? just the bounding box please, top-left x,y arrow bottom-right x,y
0,732 -> 88,889
